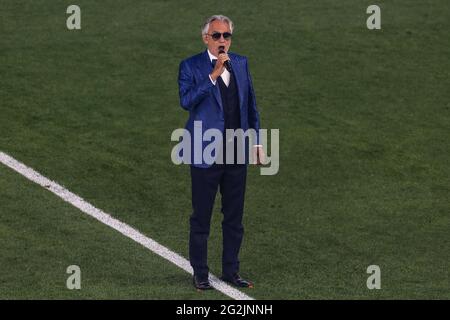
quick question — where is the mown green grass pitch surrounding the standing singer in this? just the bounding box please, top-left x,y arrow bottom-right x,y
0,0 -> 450,299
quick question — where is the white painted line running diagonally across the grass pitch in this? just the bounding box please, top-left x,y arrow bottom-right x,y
0,151 -> 253,300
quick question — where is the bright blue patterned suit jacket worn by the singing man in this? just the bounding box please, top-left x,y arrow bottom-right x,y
178,50 -> 260,168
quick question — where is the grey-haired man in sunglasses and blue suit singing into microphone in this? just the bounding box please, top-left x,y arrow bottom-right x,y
178,15 -> 264,290
